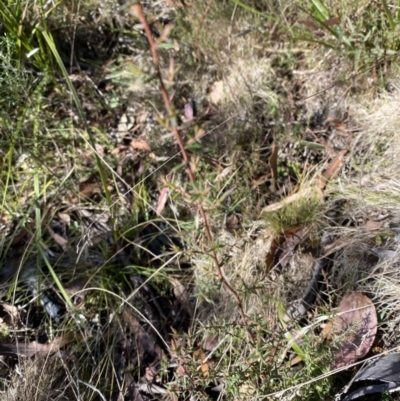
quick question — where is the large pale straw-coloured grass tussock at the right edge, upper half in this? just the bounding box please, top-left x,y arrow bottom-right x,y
338,81 -> 400,214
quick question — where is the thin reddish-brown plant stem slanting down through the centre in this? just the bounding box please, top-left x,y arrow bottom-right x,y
131,0 -> 254,342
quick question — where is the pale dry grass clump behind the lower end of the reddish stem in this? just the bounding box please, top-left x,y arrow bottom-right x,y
192,221 -> 315,329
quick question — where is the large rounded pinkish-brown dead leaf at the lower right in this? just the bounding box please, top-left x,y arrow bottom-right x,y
333,292 -> 378,369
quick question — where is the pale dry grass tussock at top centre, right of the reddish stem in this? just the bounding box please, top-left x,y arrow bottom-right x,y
175,2 -> 288,117
